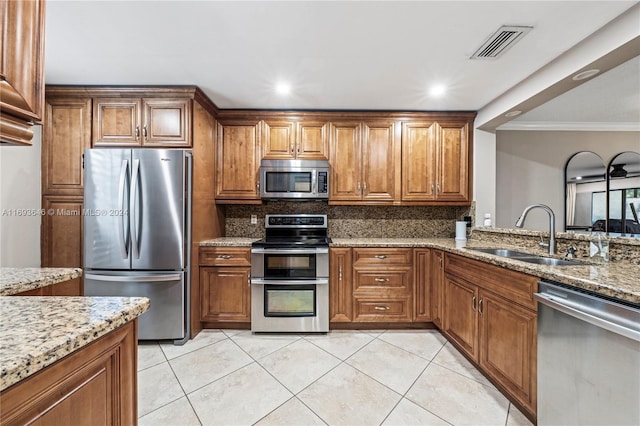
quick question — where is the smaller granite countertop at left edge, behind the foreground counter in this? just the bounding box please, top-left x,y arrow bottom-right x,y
0,268 -> 82,296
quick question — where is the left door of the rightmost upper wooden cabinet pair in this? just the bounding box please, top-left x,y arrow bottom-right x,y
402,122 -> 436,201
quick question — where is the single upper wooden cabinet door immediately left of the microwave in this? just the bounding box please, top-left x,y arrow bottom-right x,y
216,120 -> 261,200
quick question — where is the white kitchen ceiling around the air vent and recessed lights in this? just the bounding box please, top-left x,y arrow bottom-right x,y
45,0 -> 640,121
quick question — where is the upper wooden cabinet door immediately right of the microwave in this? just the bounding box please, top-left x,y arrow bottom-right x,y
329,121 -> 362,201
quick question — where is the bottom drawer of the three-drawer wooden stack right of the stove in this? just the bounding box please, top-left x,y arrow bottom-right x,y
353,297 -> 411,322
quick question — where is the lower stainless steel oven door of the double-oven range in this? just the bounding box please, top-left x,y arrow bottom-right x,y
251,278 -> 329,333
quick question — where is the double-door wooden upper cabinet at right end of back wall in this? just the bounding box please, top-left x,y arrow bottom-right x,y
402,120 -> 471,204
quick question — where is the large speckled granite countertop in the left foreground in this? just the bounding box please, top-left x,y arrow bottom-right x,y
0,296 -> 149,390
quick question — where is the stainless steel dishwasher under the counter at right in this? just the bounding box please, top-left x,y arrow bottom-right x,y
535,281 -> 640,426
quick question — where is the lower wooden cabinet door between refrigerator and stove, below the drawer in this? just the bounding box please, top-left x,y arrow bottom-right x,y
200,267 -> 251,322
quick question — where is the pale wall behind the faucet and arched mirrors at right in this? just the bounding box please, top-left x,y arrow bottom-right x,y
494,131 -> 640,230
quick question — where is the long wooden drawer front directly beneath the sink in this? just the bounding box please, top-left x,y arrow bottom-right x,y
445,253 -> 538,310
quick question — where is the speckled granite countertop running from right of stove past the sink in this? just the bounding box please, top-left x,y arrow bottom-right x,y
331,238 -> 640,304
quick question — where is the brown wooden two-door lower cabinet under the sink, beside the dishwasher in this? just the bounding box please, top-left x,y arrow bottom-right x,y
442,253 -> 537,420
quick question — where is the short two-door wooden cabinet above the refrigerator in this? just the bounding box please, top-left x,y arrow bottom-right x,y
93,98 -> 191,148
